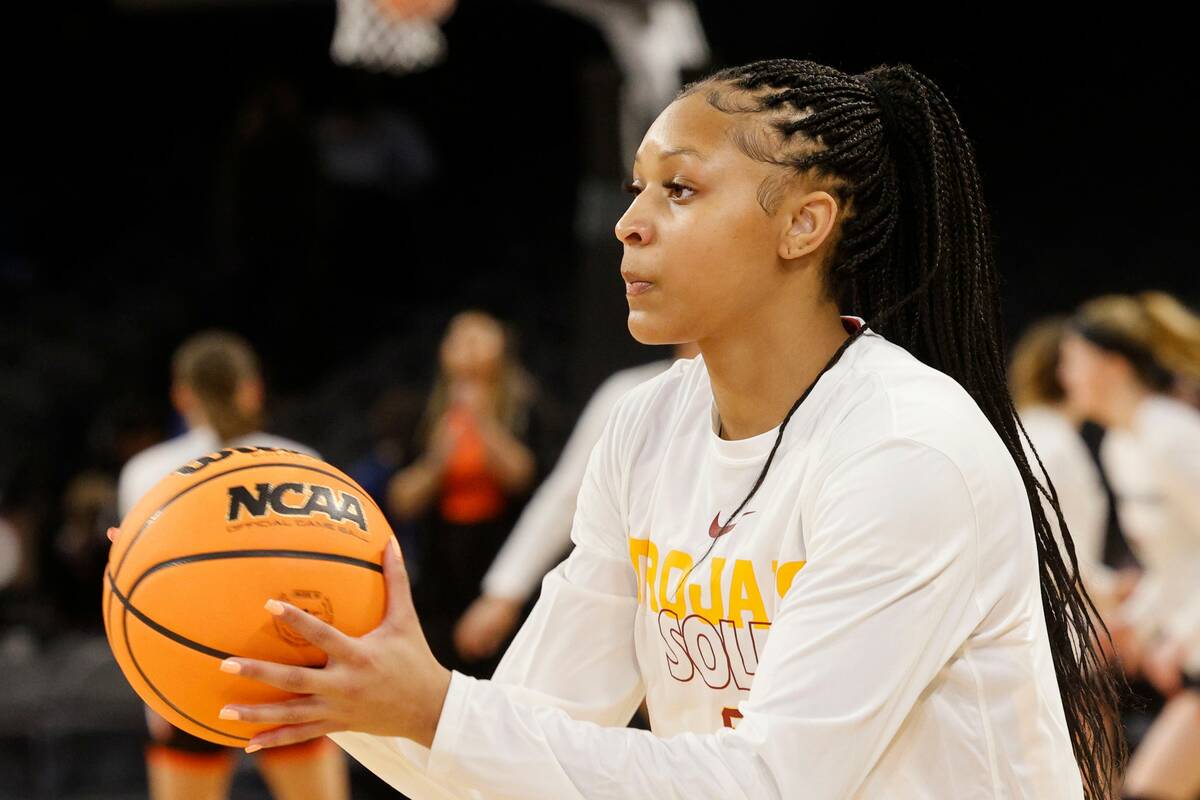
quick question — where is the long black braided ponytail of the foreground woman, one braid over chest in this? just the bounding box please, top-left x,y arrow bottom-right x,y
677,59 -> 1127,800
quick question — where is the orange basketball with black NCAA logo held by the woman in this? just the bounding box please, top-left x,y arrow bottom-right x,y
102,447 -> 392,747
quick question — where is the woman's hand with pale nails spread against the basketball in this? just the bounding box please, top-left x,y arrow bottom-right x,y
221,542 -> 450,752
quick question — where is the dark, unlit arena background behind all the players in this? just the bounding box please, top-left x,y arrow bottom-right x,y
0,0 -> 1200,800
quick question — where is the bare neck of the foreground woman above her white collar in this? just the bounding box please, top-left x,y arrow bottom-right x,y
700,305 -> 850,439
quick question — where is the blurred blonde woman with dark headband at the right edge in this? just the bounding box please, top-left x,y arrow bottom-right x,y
1060,291 -> 1200,800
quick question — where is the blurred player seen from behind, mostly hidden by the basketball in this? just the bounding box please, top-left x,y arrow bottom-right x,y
116,331 -> 349,800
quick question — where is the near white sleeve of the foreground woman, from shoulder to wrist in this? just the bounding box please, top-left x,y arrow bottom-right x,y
428,438 -> 980,800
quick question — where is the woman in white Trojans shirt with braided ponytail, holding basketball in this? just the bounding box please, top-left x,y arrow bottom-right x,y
126,59 -> 1121,800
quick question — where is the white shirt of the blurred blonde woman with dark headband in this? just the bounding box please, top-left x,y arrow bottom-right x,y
1100,395 -> 1200,673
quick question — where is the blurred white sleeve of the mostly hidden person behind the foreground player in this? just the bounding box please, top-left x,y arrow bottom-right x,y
482,359 -> 671,603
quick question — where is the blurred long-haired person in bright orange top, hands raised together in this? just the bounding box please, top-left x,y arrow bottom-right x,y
388,311 -> 547,676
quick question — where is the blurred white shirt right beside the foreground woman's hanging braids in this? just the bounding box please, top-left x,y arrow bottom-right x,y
1020,405 -> 1116,612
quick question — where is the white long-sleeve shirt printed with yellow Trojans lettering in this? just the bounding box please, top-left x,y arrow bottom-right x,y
331,318 -> 1082,800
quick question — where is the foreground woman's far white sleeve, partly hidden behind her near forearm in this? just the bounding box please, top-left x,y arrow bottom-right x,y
330,381 -> 644,800
